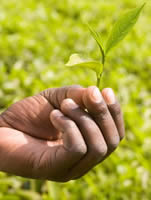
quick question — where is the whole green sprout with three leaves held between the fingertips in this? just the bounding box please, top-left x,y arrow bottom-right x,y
66,3 -> 145,87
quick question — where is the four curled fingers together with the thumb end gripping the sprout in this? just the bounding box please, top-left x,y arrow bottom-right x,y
40,86 -> 124,180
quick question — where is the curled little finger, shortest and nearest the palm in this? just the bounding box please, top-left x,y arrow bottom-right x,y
50,110 -> 87,180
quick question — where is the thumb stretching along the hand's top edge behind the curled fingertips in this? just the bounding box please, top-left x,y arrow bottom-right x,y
40,85 -> 86,109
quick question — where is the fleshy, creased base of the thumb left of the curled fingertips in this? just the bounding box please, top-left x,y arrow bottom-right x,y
2,95 -> 60,140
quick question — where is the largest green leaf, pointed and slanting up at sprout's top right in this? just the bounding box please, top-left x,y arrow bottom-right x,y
105,3 -> 145,54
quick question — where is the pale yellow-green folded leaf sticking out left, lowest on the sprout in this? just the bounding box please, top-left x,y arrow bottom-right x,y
66,53 -> 103,76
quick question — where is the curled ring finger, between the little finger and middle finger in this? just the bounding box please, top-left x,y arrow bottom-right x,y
61,99 -> 107,178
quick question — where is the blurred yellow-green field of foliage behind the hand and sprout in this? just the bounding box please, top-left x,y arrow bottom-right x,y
0,0 -> 151,200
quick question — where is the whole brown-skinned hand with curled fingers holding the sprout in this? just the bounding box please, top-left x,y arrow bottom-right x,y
0,86 -> 124,182
